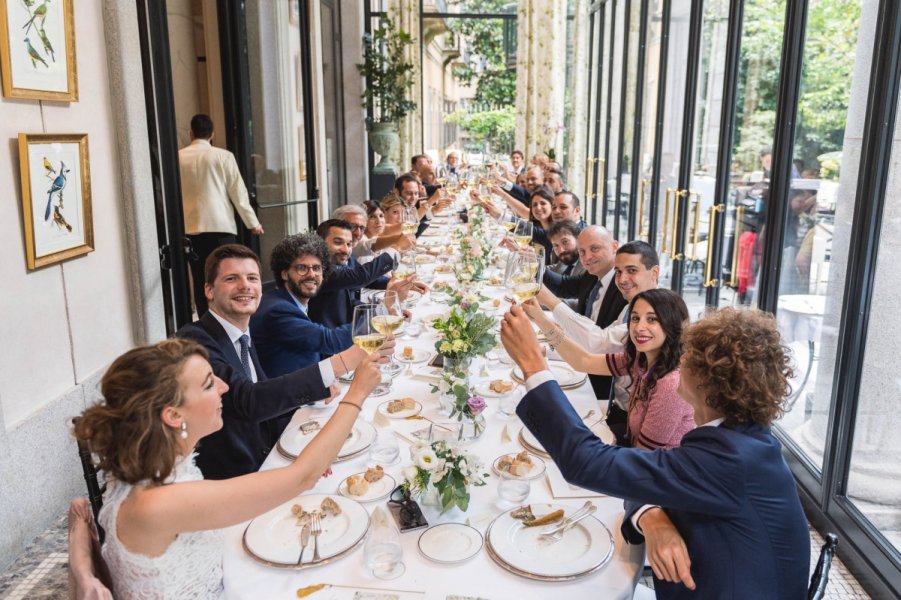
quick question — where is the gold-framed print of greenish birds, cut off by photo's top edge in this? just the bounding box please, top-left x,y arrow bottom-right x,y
0,0 -> 78,102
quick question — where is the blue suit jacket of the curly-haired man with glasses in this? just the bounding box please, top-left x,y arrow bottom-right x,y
250,288 -> 353,377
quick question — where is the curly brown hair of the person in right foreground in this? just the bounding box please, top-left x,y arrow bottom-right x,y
682,308 -> 793,425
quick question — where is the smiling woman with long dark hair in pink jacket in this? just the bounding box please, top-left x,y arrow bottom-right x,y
532,289 -> 694,450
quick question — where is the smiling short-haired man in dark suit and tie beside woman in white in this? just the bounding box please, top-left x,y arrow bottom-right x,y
175,244 -> 366,479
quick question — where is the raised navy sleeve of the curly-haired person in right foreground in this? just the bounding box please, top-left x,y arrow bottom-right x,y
516,381 -> 745,517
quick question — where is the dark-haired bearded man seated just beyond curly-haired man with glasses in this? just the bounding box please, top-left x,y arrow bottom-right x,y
309,219 -> 428,327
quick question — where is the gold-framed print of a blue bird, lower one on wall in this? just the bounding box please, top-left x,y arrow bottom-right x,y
19,133 -> 94,270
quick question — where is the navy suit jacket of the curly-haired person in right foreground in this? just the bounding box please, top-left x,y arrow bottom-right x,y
516,381 -> 810,600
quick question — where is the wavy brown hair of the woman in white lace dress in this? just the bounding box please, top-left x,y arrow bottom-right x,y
74,338 -> 208,484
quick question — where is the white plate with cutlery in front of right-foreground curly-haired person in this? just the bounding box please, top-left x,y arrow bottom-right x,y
485,503 -> 613,581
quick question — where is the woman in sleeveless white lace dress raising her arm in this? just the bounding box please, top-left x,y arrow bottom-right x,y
75,338 -> 384,600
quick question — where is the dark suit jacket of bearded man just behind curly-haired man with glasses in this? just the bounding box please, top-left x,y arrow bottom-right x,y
309,253 -> 394,327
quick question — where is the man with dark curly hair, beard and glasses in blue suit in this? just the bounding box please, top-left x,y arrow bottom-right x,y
250,233 -> 352,376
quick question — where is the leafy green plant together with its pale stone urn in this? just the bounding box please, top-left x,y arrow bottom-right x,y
357,19 -> 416,175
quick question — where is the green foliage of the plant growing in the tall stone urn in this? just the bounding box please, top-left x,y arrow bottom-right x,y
357,19 -> 416,125
